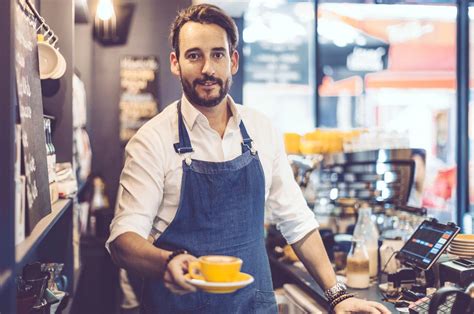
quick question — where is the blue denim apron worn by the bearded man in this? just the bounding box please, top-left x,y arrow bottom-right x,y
142,103 -> 277,313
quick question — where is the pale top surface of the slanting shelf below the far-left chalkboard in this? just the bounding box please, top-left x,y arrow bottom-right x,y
15,199 -> 72,265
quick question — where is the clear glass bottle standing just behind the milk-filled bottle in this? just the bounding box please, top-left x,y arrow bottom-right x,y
353,204 -> 379,277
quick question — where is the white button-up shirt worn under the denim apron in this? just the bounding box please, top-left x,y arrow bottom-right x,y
106,96 -> 318,248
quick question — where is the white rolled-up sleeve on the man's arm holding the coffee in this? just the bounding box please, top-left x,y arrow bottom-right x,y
106,129 -> 163,254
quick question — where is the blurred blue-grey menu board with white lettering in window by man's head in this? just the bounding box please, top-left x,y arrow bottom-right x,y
242,1 -> 314,85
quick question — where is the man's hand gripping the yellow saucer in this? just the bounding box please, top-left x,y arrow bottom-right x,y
163,254 -> 196,295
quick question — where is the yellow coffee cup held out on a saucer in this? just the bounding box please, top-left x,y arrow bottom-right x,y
189,255 -> 242,282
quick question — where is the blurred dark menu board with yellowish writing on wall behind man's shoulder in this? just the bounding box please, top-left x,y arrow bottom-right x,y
120,56 -> 158,142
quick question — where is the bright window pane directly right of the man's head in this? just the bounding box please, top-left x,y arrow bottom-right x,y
243,1 -> 316,133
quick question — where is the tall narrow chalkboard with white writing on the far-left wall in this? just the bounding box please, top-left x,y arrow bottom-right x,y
15,4 -> 51,232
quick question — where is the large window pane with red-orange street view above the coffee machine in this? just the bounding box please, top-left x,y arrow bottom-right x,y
317,3 -> 457,222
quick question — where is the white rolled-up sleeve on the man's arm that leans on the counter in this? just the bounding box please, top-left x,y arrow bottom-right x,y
266,129 -> 319,244
